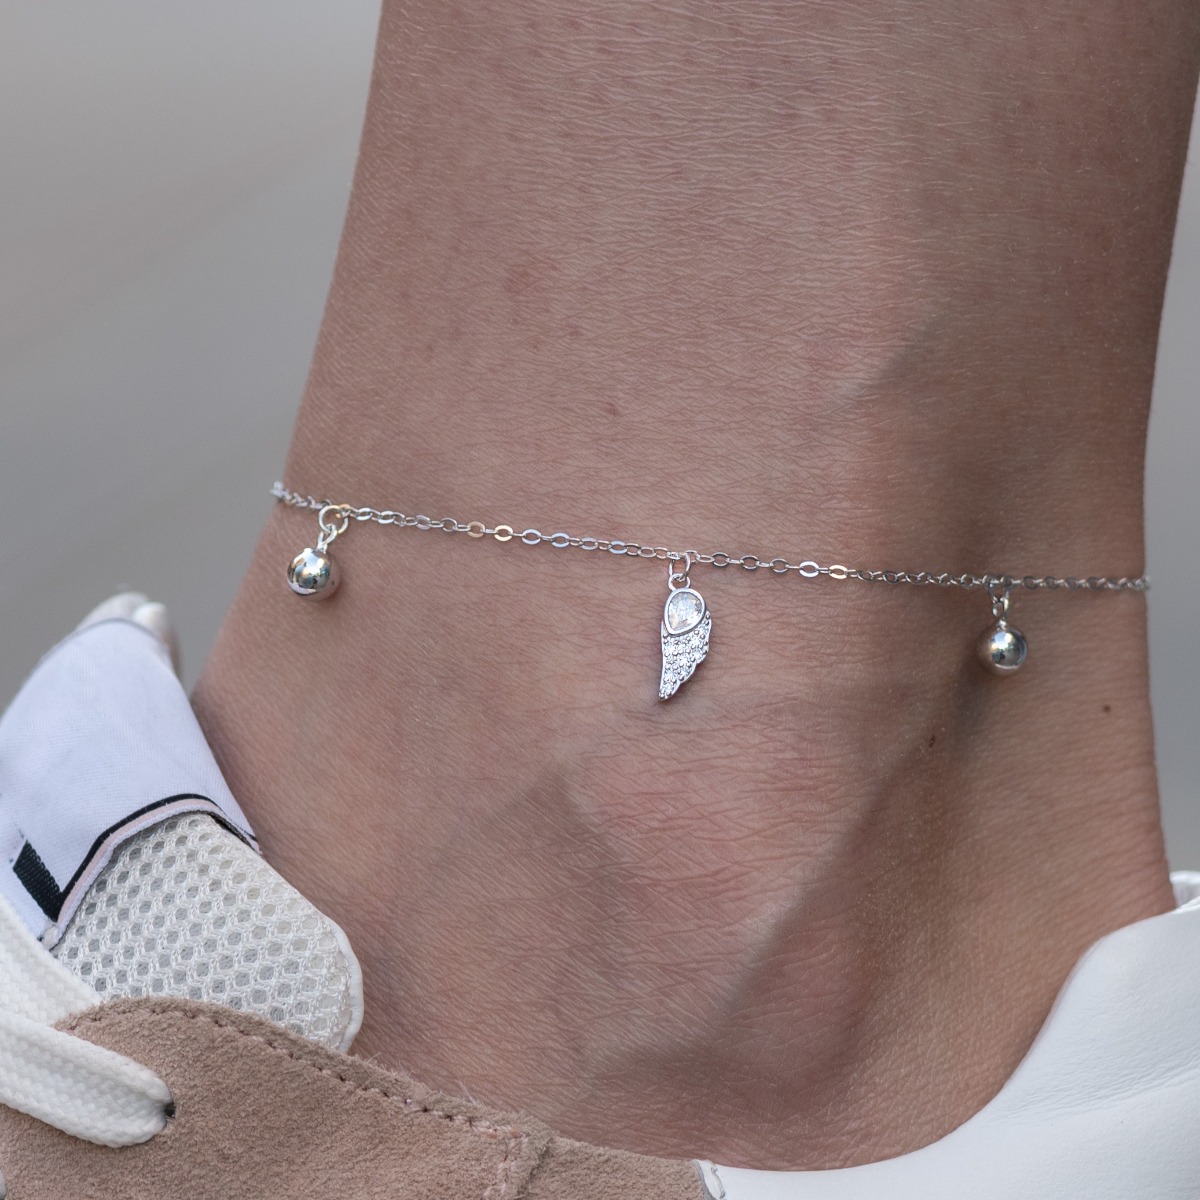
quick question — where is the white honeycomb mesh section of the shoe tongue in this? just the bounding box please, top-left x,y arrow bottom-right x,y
53,812 -> 361,1049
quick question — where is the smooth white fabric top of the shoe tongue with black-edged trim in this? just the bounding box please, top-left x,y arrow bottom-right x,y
0,619 -> 257,942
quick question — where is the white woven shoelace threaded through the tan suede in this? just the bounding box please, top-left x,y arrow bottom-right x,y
0,896 -> 172,1200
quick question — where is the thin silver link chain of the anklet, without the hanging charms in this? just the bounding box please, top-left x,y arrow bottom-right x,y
271,484 -> 1150,592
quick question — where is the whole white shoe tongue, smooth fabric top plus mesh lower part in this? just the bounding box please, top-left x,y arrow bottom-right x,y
0,594 -> 362,1050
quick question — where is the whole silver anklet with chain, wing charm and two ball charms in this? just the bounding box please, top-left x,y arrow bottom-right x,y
271,484 -> 1150,700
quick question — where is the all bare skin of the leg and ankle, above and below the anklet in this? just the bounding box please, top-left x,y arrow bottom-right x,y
196,0 -> 1200,1166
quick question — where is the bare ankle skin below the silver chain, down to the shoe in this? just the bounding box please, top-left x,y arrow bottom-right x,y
197,487 -> 1169,1165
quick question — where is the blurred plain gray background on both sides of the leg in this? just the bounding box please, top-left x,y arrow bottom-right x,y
0,0 -> 1200,866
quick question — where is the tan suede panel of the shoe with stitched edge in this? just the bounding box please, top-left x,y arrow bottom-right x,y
0,1000 -> 707,1200
